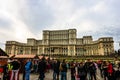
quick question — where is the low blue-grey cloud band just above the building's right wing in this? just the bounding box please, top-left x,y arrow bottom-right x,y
78,26 -> 120,43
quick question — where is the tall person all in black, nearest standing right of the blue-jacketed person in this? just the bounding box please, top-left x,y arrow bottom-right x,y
38,57 -> 46,80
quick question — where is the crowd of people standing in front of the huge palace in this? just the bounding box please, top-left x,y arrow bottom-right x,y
0,57 -> 120,80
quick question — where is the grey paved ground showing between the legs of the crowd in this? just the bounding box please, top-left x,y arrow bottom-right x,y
20,70 -> 103,80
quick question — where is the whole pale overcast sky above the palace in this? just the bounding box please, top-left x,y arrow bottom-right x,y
0,0 -> 120,49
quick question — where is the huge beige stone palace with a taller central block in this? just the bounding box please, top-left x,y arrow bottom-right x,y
5,29 -> 114,56
